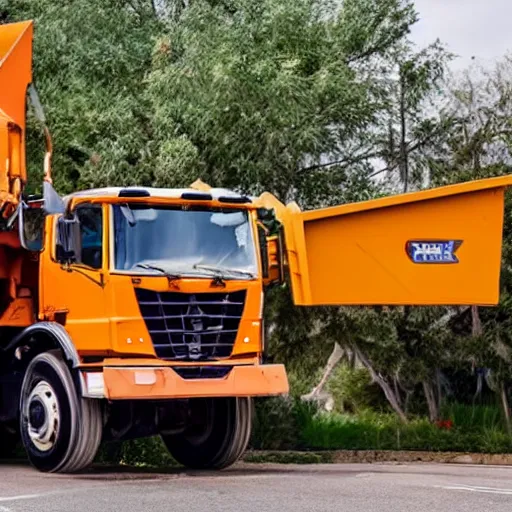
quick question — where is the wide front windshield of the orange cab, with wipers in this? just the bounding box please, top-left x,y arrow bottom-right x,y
113,204 -> 257,279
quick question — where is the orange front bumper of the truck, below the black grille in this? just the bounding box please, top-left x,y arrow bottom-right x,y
82,364 -> 289,400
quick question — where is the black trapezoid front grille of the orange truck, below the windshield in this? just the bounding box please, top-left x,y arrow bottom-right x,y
135,288 -> 246,361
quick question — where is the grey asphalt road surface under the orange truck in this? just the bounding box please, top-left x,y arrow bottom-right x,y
0,464 -> 512,512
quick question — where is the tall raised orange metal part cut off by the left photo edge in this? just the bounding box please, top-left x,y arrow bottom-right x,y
0,21 -> 33,219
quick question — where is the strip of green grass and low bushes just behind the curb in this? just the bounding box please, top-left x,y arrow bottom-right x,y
251,399 -> 512,453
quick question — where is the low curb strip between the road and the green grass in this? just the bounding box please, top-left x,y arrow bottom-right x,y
243,450 -> 512,466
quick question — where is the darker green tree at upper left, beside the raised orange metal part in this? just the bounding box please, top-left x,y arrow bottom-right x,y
3,0 -> 164,193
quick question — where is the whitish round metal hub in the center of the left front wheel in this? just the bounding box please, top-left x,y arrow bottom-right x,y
26,381 -> 60,451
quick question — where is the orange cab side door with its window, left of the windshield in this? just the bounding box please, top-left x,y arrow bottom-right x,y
39,204 -> 110,353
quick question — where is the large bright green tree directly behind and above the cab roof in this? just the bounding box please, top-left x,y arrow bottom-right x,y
143,0 -> 414,206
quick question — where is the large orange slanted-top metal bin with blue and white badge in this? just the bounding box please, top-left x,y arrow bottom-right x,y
280,176 -> 512,306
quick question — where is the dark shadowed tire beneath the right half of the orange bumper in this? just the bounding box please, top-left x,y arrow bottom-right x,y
161,398 -> 253,469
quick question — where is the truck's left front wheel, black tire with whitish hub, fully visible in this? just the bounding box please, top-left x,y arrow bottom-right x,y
20,351 -> 102,473
